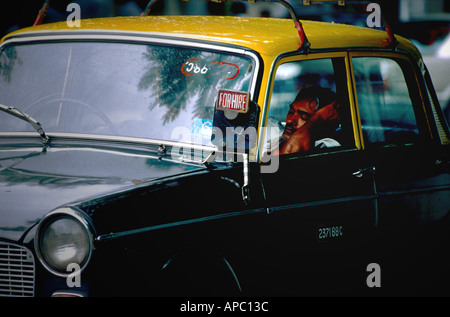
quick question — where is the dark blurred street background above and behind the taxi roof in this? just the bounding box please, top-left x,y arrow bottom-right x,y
0,0 -> 450,120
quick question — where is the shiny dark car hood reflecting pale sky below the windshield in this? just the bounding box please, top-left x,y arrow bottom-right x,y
0,142 -> 204,241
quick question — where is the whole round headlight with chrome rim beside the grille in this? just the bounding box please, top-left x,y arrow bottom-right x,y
35,209 -> 93,276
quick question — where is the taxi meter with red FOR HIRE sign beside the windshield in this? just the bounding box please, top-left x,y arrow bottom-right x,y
211,90 -> 260,153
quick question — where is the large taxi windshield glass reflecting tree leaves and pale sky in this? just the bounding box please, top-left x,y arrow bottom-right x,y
0,41 -> 254,145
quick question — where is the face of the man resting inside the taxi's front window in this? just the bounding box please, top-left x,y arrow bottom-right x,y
283,99 -> 317,140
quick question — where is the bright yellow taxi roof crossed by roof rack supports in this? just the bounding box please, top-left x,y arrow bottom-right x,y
2,16 -> 416,56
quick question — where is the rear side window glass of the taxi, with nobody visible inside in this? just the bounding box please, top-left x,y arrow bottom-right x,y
352,57 -> 419,145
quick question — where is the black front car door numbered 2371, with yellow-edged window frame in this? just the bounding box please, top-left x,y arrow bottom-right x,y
255,53 -> 378,293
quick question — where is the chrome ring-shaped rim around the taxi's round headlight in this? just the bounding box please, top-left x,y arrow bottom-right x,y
34,207 -> 96,277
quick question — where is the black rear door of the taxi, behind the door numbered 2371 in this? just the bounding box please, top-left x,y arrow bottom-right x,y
350,52 -> 450,289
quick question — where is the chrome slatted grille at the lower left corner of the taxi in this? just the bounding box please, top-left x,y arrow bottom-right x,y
0,241 -> 35,297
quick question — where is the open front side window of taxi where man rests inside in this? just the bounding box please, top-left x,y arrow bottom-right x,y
264,57 -> 354,154
